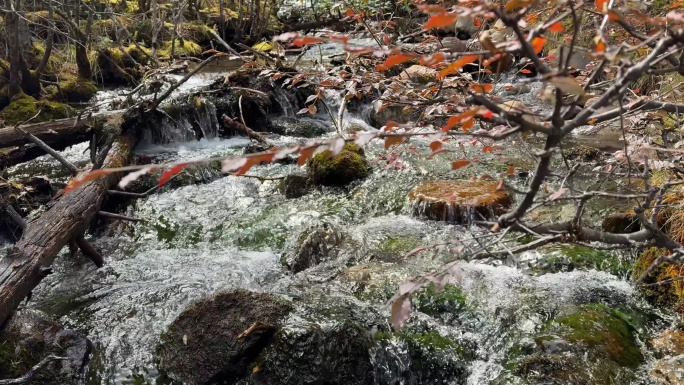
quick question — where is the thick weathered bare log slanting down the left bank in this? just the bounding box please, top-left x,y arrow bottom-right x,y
0,115 -> 137,325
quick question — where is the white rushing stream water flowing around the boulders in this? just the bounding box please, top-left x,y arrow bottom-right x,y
1,57 -> 672,385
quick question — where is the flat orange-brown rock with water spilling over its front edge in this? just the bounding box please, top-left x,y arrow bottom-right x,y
408,180 -> 513,224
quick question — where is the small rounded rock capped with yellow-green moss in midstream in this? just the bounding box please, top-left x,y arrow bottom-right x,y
307,143 -> 370,186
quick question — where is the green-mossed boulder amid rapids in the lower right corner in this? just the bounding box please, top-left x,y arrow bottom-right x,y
494,304 -> 644,385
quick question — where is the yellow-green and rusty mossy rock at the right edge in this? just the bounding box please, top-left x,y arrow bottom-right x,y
632,247 -> 684,308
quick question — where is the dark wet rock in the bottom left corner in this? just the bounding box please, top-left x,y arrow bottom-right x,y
0,310 -> 92,385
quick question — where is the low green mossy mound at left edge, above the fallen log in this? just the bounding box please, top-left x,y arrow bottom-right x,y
0,94 -> 75,125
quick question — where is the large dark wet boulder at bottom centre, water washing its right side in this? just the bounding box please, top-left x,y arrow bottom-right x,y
159,290 -> 378,385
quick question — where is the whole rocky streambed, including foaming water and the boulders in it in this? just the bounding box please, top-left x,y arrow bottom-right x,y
0,57 -> 684,385
